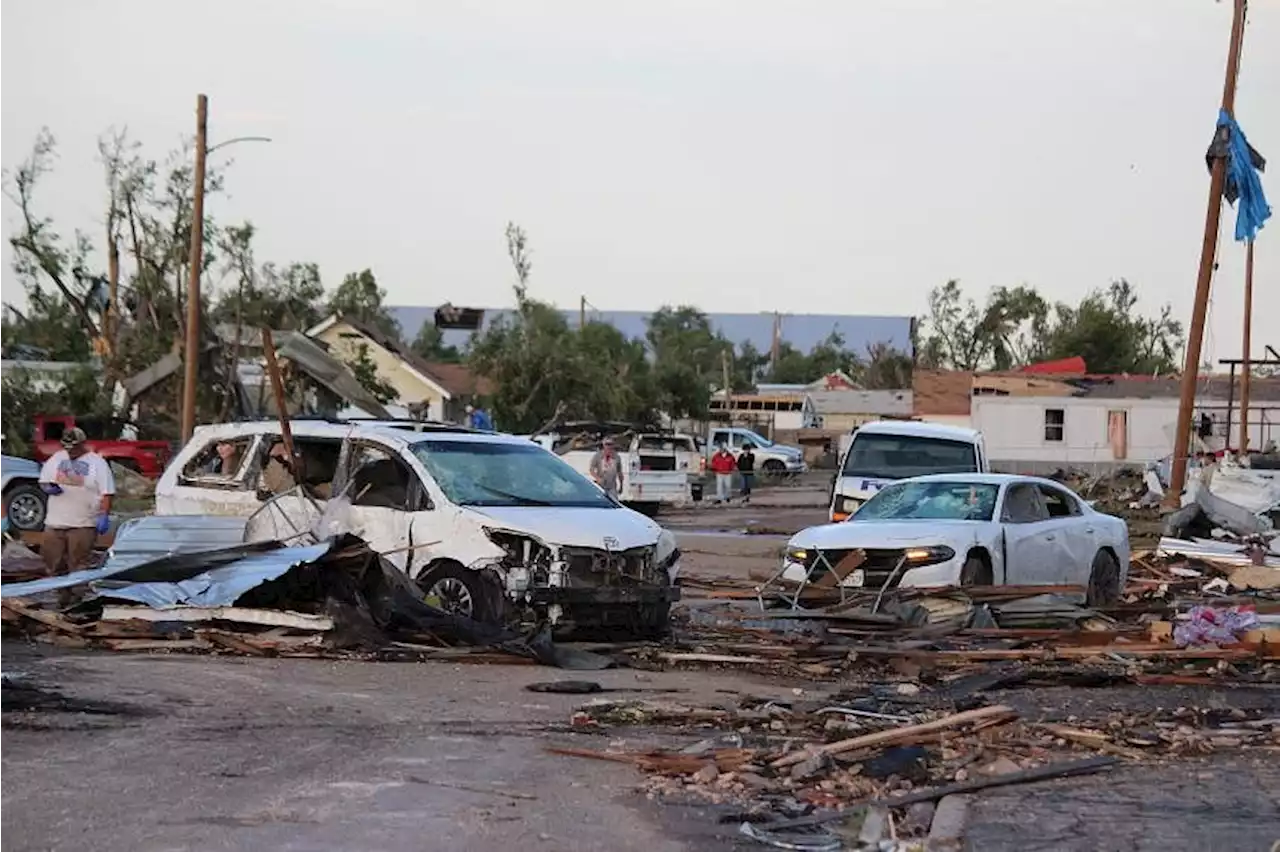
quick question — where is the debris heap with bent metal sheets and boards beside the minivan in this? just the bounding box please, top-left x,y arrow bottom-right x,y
0,519 -> 612,669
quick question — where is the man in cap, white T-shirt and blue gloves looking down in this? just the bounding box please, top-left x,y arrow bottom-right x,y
40,427 -> 115,583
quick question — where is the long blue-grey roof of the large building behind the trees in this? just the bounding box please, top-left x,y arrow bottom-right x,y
388,306 -> 911,354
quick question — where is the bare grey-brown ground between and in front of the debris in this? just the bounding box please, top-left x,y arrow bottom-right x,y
0,484 -> 1280,852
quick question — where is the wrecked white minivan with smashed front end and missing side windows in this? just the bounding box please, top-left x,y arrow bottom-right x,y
156,420 -> 680,636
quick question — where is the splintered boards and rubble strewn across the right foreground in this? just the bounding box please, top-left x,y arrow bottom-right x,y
550,677 -> 1280,848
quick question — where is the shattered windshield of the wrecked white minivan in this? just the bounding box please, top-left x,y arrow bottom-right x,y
411,439 -> 617,509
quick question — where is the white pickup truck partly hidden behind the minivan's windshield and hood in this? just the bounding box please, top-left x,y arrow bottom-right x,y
531,423 -> 692,517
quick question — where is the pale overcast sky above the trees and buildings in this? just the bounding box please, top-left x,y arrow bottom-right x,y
0,0 -> 1280,357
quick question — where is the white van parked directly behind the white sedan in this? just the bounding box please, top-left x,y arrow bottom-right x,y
829,420 -> 989,522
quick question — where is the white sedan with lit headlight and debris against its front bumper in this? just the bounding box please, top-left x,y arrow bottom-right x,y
782,473 -> 1129,605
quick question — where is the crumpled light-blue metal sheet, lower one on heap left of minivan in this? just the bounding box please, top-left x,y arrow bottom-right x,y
95,541 -> 333,609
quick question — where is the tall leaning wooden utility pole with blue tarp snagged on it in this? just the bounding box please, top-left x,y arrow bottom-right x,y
1166,0 -> 1247,504
